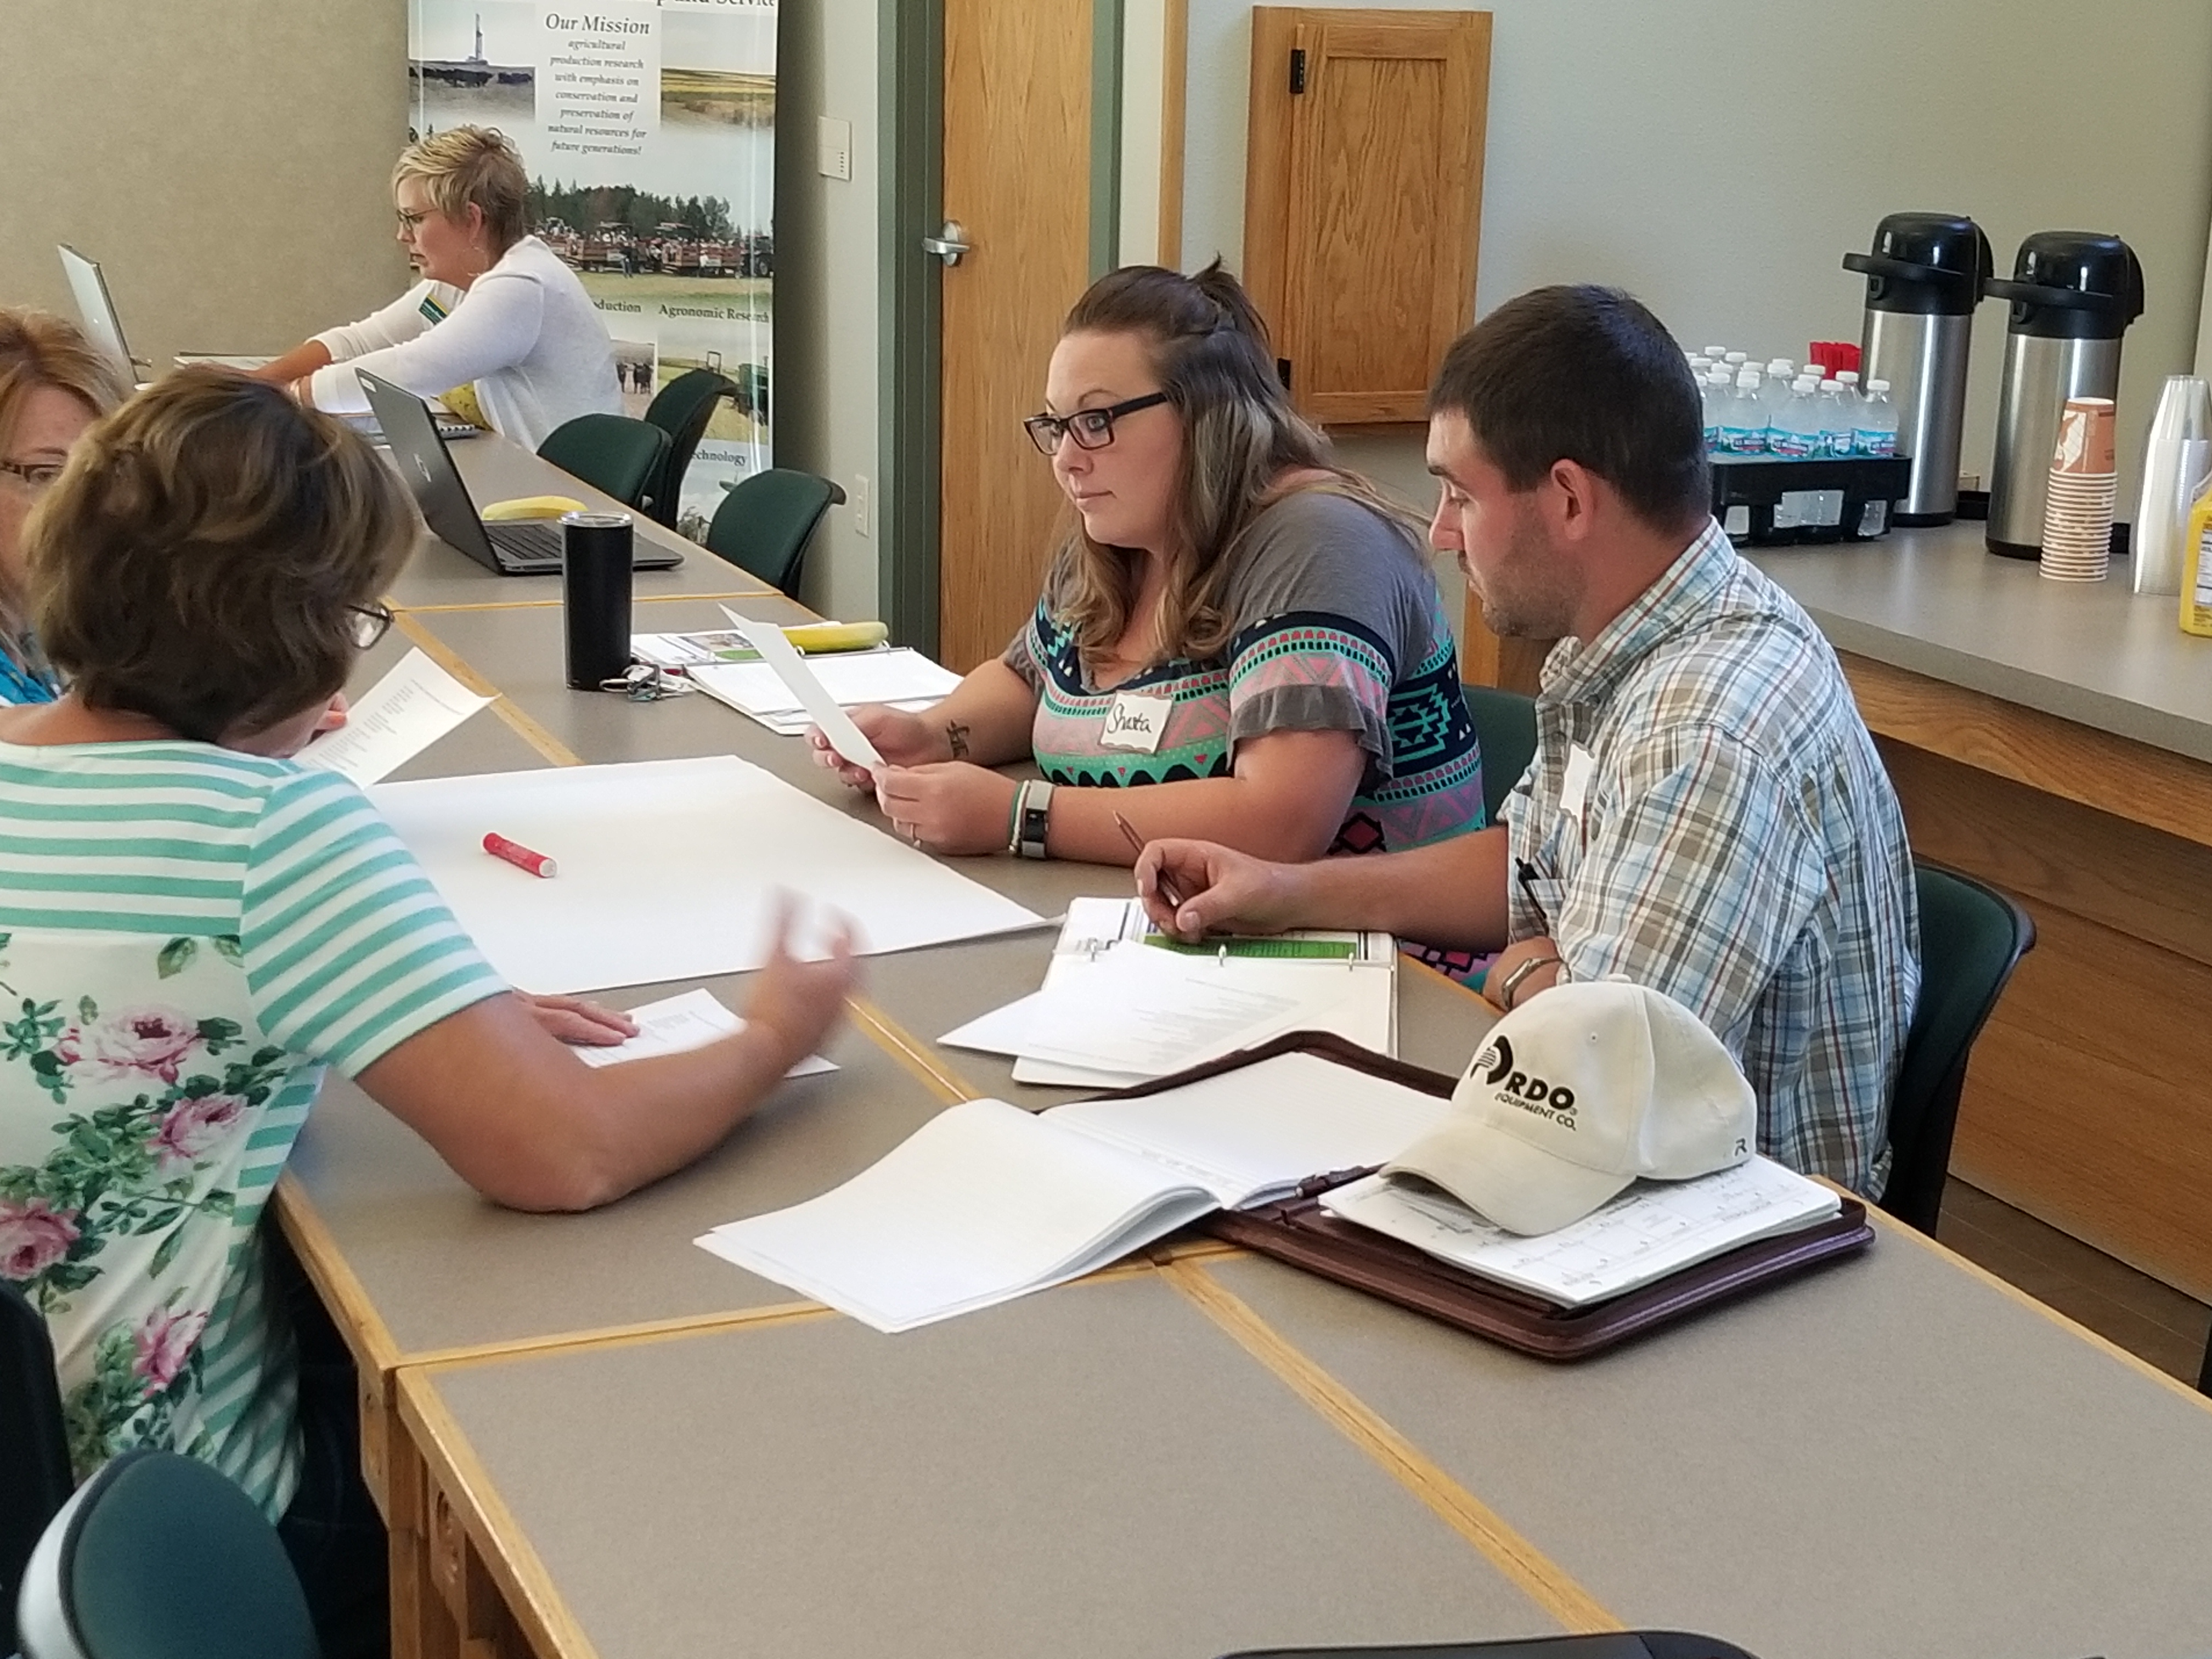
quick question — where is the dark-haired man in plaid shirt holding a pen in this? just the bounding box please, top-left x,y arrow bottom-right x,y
1137,287 -> 1920,1197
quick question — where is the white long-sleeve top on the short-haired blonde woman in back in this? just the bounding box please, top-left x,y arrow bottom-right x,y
309,236 -> 622,449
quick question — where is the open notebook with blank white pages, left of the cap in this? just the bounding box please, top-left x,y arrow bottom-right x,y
697,1055 -> 1451,1331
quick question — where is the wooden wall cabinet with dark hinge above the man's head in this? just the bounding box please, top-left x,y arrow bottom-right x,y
1243,7 -> 1491,427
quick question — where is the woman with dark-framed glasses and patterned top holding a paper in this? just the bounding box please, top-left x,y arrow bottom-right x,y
810,261 -> 1482,971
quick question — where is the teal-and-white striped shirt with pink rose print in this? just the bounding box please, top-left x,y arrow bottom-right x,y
0,741 -> 504,1520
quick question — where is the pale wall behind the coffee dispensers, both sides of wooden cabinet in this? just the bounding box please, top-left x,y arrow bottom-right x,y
1183,0 -> 2212,506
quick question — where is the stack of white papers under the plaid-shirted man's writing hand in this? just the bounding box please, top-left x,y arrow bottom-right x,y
940,898 -> 1398,1088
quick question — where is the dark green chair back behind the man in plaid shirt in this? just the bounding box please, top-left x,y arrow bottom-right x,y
1882,858 -> 2035,1237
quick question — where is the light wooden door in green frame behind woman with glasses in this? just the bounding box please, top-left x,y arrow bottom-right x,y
938,0 -> 1091,673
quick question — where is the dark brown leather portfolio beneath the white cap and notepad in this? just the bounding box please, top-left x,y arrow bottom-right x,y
1097,1031 -> 1874,1361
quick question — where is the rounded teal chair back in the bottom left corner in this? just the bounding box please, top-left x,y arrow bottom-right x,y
18,1451 -> 319,1659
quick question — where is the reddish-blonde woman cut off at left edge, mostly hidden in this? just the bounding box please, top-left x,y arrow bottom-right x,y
0,305 -> 131,703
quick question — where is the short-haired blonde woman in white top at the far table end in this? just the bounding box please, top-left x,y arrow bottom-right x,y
255,126 -> 622,449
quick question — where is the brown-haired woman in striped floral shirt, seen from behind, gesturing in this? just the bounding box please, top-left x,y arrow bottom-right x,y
0,369 -> 851,1657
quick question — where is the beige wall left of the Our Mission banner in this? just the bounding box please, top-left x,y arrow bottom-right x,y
0,0 -> 407,363
